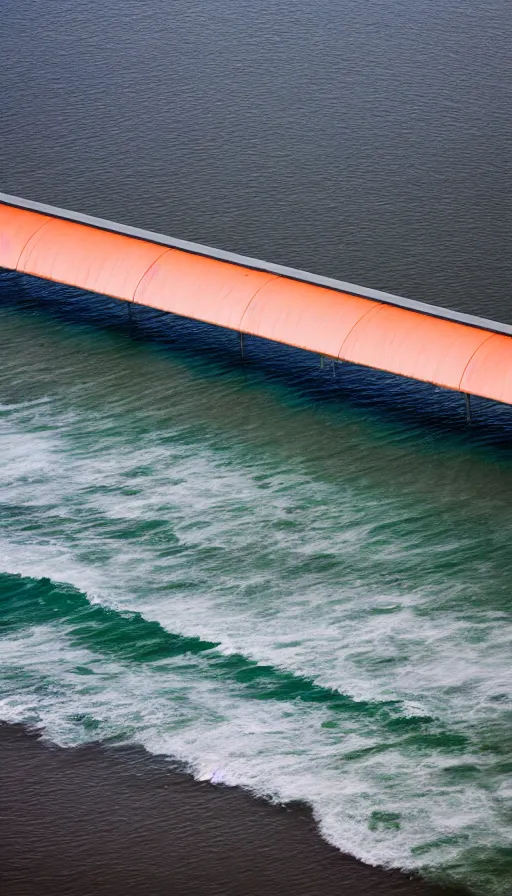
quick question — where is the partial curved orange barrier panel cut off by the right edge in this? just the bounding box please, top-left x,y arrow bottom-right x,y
460,333 -> 512,404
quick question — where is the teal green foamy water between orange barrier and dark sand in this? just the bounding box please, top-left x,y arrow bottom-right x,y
0,280 -> 512,896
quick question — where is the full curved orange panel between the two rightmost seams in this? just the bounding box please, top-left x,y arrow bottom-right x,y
339,305 -> 489,389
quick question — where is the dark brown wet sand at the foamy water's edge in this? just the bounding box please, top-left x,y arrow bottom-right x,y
0,725 -> 466,896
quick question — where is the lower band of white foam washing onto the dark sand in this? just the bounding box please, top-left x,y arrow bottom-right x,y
0,626 -> 505,880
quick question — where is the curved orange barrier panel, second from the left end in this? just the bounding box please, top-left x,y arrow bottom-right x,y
18,218 -> 166,299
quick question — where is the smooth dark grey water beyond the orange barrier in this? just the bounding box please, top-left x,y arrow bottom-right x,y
0,0 -> 512,322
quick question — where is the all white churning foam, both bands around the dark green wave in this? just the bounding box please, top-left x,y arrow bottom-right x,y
0,332 -> 512,892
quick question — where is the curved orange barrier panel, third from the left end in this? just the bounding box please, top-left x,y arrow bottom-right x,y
134,249 -> 272,330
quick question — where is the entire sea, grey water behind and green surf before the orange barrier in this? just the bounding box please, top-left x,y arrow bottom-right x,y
0,0 -> 512,896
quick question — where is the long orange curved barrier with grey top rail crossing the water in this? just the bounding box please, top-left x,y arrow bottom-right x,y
0,193 -> 512,411
